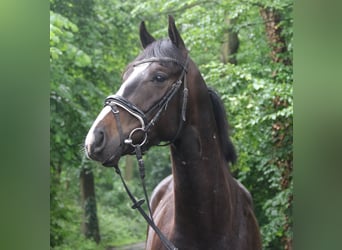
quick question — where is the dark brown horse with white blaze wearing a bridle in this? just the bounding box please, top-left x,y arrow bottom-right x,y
85,16 -> 262,250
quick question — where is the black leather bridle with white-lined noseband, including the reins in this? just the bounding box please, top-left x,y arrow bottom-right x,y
104,56 -> 189,250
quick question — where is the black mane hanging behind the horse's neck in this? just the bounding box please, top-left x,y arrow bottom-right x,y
208,88 -> 237,164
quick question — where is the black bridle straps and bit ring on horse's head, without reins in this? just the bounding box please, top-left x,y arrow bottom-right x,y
104,57 -> 189,148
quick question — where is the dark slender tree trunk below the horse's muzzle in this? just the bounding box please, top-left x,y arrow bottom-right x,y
80,168 -> 100,243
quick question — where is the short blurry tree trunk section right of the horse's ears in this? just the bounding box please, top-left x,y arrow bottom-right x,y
221,18 -> 240,65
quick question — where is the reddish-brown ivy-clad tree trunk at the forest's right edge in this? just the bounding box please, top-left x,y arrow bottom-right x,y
260,3 -> 293,250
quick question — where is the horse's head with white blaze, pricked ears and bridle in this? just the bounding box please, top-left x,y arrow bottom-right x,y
85,16 -> 189,166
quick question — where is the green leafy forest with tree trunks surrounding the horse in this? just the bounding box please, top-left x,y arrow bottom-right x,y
50,0 -> 293,250
